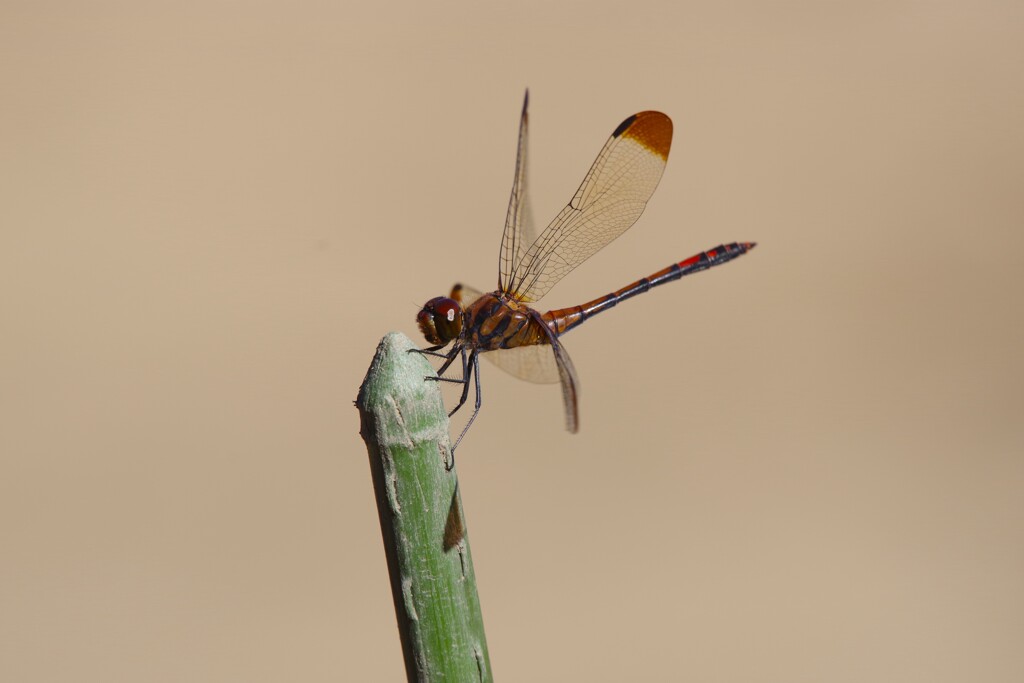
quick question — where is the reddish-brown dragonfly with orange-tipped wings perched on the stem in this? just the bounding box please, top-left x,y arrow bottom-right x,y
414,92 -> 755,467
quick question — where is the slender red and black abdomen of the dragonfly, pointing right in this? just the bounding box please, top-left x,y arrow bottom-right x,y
543,242 -> 757,335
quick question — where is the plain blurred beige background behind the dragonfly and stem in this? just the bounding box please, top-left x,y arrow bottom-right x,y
0,1 -> 1024,683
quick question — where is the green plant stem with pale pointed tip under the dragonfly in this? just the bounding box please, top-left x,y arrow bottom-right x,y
355,333 -> 493,683
